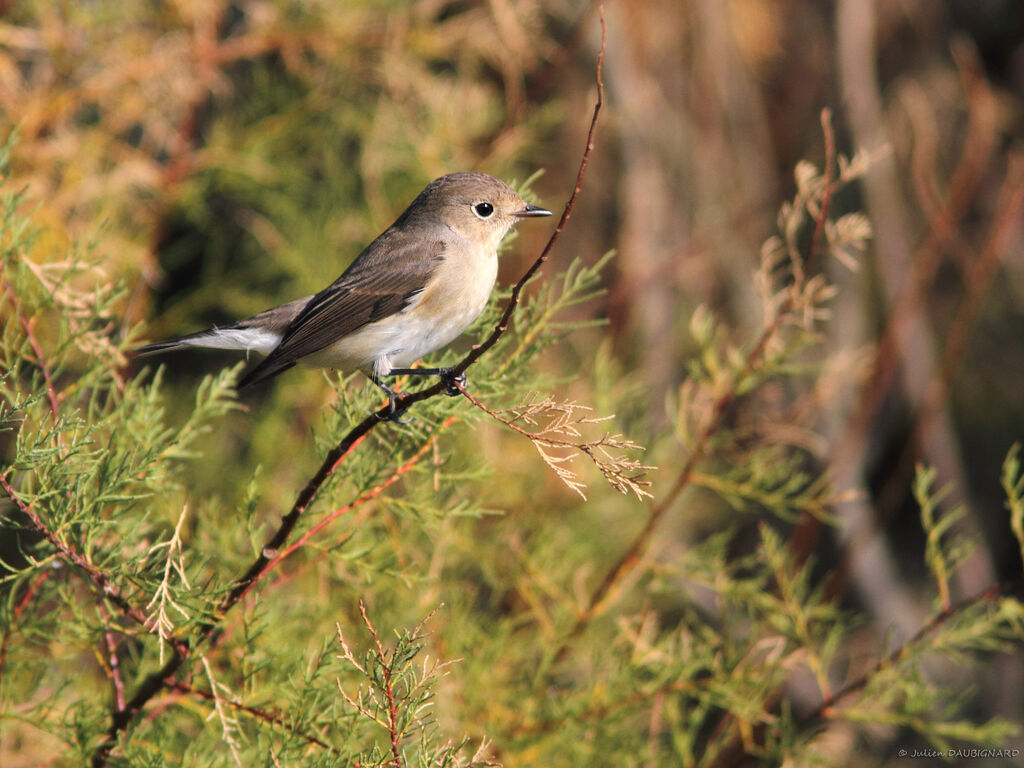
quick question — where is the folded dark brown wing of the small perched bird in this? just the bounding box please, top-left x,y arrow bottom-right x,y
239,229 -> 445,387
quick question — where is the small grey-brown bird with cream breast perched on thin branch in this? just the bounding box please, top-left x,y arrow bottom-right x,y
138,172 -> 551,421
